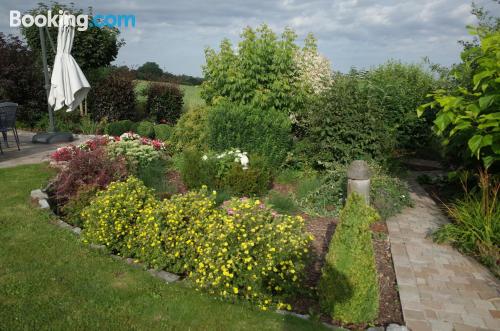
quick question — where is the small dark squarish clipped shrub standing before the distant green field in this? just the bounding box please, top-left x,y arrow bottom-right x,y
146,83 -> 184,125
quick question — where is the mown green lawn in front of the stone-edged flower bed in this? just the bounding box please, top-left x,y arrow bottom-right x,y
0,164 -> 326,330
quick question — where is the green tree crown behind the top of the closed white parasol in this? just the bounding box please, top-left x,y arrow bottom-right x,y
21,1 -> 125,72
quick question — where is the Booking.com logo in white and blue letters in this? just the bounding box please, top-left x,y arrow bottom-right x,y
10,10 -> 135,31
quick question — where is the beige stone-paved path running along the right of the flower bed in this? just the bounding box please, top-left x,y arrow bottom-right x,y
387,178 -> 500,331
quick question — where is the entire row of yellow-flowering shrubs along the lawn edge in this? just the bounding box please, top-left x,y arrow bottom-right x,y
82,177 -> 312,309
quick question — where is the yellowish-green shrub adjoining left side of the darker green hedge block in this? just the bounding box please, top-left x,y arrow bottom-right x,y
171,107 -> 209,151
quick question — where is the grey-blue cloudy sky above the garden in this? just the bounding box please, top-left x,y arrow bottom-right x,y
0,0 -> 500,75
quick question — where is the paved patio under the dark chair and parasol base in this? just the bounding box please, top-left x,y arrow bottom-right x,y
0,130 -> 88,168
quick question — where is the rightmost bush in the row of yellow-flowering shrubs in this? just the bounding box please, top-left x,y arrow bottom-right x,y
189,198 -> 313,309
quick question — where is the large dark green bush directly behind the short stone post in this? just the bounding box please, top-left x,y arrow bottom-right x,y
305,72 -> 396,167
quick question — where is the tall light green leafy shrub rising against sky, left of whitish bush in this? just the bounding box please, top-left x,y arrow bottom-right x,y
201,25 -> 307,115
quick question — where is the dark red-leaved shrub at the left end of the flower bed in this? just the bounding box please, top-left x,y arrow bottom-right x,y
54,148 -> 127,204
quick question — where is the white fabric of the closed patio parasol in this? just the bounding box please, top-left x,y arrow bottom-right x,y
49,13 -> 90,111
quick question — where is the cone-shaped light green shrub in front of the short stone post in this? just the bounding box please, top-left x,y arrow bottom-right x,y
319,194 -> 379,323
